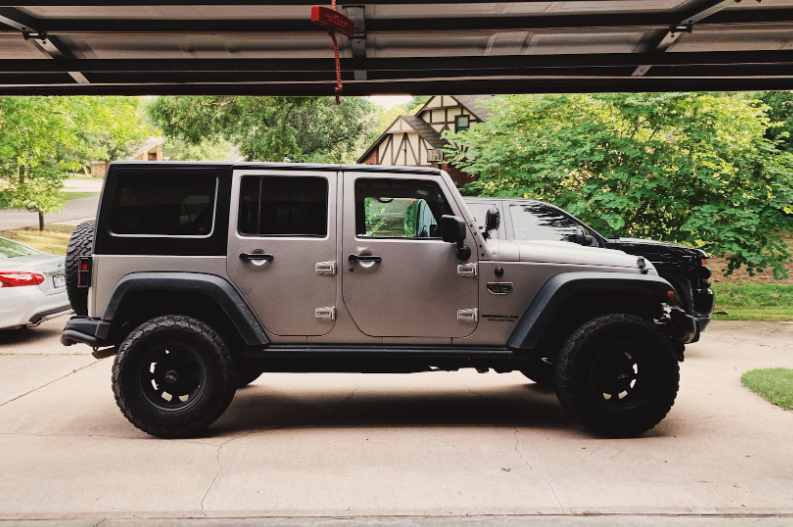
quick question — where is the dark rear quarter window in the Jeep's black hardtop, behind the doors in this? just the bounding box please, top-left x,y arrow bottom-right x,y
110,173 -> 217,236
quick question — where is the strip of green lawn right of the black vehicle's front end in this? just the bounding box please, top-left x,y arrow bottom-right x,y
713,284 -> 793,322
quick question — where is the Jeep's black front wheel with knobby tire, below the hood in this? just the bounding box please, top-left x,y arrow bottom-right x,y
556,314 -> 680,437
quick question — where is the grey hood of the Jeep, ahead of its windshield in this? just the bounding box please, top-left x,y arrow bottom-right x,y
488,240 -> 655,274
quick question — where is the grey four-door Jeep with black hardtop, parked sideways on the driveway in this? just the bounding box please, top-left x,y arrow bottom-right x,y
61,162 -> 696,437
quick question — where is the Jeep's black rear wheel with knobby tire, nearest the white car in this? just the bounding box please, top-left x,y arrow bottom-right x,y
113,315 -> 237,437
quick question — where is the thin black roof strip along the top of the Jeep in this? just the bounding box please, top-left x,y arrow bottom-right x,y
105,161 -> 441,176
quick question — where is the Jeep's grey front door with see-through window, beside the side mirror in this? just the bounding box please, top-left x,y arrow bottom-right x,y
340,173 -> 479,337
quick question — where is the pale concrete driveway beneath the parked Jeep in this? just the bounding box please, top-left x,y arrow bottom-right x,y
0,319 -> 793,526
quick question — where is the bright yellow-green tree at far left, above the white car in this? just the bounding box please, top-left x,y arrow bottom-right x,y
0,97 -> 148,228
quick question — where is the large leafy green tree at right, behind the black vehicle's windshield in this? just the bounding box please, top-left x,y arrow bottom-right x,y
446,93 -> 793,277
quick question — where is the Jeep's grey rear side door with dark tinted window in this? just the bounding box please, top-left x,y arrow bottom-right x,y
226,170 -> 337,336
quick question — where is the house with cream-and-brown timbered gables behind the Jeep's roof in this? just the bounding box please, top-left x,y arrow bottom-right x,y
358,95 -> 493,187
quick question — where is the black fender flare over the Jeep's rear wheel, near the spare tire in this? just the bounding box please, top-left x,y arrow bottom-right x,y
96,272 -> 270,346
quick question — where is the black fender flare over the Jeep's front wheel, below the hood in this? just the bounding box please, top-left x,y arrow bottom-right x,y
507,272 -> 675,349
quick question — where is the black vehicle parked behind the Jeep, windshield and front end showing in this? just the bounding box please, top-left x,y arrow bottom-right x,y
465,198 -> 714,331
